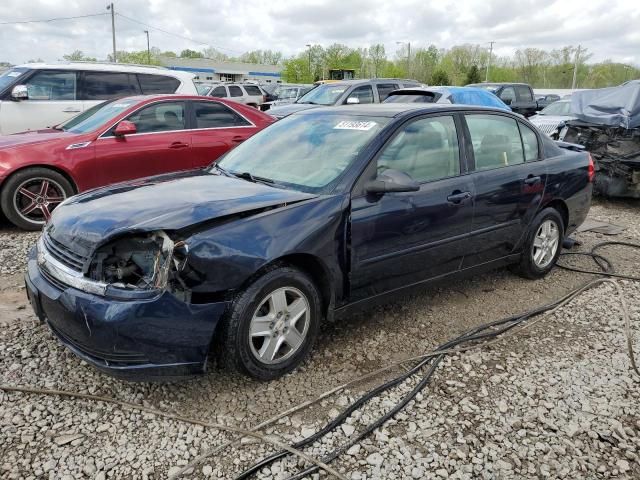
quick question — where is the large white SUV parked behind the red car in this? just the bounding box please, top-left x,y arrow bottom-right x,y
0,62 -> 198,135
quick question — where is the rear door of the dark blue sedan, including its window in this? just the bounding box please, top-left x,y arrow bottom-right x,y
464,113 -> 547,267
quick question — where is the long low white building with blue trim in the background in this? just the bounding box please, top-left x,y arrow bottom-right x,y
160,57 -> 282,83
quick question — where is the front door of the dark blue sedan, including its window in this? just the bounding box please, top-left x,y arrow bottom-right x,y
350,115 -> 474,300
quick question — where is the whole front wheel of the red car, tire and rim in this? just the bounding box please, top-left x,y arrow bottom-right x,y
0,168 -> 74,230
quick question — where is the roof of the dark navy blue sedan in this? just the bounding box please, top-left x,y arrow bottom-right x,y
292,103 -> 509,118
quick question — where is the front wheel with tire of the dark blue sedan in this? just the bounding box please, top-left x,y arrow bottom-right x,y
220,266 -> 322,380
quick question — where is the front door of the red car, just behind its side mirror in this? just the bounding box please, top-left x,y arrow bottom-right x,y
95,101 -> 193,185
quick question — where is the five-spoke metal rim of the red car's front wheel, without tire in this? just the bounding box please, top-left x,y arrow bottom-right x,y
13,177 -> 67,224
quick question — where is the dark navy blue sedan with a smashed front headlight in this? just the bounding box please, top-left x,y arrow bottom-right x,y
26,104 -> 593,379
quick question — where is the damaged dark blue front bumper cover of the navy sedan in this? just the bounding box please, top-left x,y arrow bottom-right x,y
25,248 -> 228,380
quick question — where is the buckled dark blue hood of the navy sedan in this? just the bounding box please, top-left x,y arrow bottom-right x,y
46,170 -> 315,256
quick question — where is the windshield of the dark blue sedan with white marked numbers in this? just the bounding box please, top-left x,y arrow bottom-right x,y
218,113 -> 389,193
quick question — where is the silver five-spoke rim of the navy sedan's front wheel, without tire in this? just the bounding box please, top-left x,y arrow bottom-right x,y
249,287 -> 311,365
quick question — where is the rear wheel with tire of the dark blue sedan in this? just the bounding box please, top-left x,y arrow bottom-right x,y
513,208 -> 564,279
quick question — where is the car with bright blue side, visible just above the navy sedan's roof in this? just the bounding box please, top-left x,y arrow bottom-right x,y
383,87 -> 511,112
